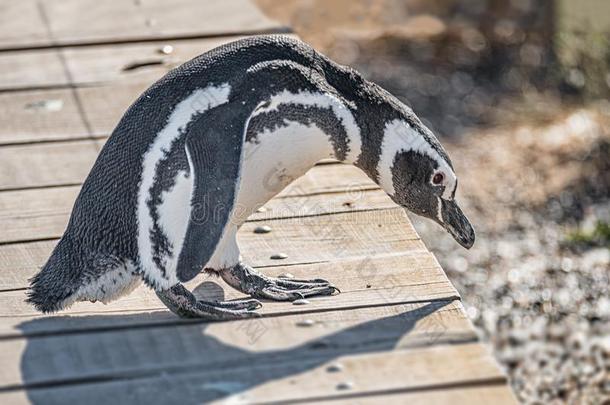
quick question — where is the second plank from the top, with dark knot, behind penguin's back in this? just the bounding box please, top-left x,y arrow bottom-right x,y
0,35 -> 295,93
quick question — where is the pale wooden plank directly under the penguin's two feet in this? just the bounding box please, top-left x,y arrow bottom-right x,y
0,255 -> 458,338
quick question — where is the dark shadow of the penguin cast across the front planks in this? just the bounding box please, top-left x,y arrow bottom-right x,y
20,282 -> 449,405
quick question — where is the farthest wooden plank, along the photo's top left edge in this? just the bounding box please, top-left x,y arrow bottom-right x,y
0,0 -> 290,50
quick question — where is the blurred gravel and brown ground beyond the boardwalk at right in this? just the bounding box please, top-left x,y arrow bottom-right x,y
257,0 -> 610,404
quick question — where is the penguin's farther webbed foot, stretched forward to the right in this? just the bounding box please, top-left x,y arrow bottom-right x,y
220,263 -> 340,301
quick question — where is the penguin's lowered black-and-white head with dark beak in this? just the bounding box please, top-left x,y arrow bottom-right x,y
378,119 -> 475,249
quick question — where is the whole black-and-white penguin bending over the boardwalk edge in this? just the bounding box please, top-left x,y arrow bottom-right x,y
29,36 -> 475,319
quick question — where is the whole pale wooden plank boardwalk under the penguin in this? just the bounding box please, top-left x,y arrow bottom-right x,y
0,0 -> 515,405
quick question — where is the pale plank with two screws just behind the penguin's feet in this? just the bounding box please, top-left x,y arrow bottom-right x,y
0,209 -> 425,289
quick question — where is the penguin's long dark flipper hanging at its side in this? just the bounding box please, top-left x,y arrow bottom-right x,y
176,102 -> 250,282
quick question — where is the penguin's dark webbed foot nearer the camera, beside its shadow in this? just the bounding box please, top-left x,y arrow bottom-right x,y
157,284 -> 262,321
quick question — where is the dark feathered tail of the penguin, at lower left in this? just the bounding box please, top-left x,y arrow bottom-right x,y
26,238 -> 81,313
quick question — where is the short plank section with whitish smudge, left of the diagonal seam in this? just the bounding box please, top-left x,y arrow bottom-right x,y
0,88 -> 89,145
